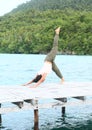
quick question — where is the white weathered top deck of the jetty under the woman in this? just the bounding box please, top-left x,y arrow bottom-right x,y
0,82 -> 92,103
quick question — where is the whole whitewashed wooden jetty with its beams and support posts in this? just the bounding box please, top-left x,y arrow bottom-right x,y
0,82 -> 92,130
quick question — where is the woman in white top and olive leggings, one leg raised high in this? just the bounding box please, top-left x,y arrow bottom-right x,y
24,27 -> 64,87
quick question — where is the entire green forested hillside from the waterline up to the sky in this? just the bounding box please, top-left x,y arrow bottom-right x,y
0,0 -> 92,55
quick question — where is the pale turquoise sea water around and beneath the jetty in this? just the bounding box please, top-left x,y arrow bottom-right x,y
0,54 -> 92,130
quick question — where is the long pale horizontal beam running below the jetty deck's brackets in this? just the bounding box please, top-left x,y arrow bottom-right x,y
0,99 -> 92,114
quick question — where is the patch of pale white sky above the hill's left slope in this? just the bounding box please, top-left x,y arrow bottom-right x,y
0,0 -> 30,16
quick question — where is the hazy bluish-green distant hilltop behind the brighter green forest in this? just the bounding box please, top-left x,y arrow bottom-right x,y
13,0 -> 92,12
